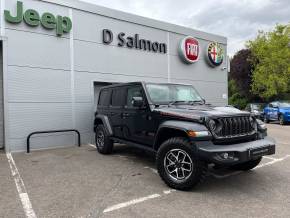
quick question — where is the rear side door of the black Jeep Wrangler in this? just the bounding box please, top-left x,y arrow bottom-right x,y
108,87 -> 126,138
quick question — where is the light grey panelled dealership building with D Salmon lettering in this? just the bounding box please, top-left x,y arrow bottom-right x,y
0,0 -> 228,151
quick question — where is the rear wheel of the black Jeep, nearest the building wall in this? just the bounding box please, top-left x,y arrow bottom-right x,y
95,124 -> 114,154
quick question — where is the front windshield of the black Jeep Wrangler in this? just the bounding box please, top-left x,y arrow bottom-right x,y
146,84 -> 203,104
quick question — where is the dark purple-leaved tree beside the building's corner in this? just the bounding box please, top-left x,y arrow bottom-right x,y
229,49 -> 253,98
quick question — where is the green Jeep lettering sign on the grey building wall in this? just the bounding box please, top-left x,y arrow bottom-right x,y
4,1 -> 72,36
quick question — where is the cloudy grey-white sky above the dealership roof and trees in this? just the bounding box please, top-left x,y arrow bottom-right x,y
82,0 -> 290,56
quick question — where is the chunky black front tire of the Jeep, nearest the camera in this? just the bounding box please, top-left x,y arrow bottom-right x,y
156,137 -> 208,190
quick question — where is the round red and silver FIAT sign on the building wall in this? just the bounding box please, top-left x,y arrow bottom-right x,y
179,36 -> 199,64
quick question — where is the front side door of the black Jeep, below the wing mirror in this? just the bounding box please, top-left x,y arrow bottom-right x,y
122,85 -> 156,146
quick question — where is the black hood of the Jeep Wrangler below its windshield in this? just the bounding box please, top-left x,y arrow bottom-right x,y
154,104 -> 250,120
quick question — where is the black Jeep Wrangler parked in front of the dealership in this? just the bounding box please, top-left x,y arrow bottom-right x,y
94,82 -> 275,190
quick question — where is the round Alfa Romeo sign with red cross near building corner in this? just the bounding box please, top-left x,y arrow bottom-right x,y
207,42 -> 224,67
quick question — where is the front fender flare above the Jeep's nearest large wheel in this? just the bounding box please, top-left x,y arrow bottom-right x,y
153,120 -> 208,149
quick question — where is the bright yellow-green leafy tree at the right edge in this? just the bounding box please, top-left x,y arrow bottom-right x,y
247,25 -> 290,100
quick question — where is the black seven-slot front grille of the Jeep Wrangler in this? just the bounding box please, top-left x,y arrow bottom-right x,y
212,116 -> 255,138
